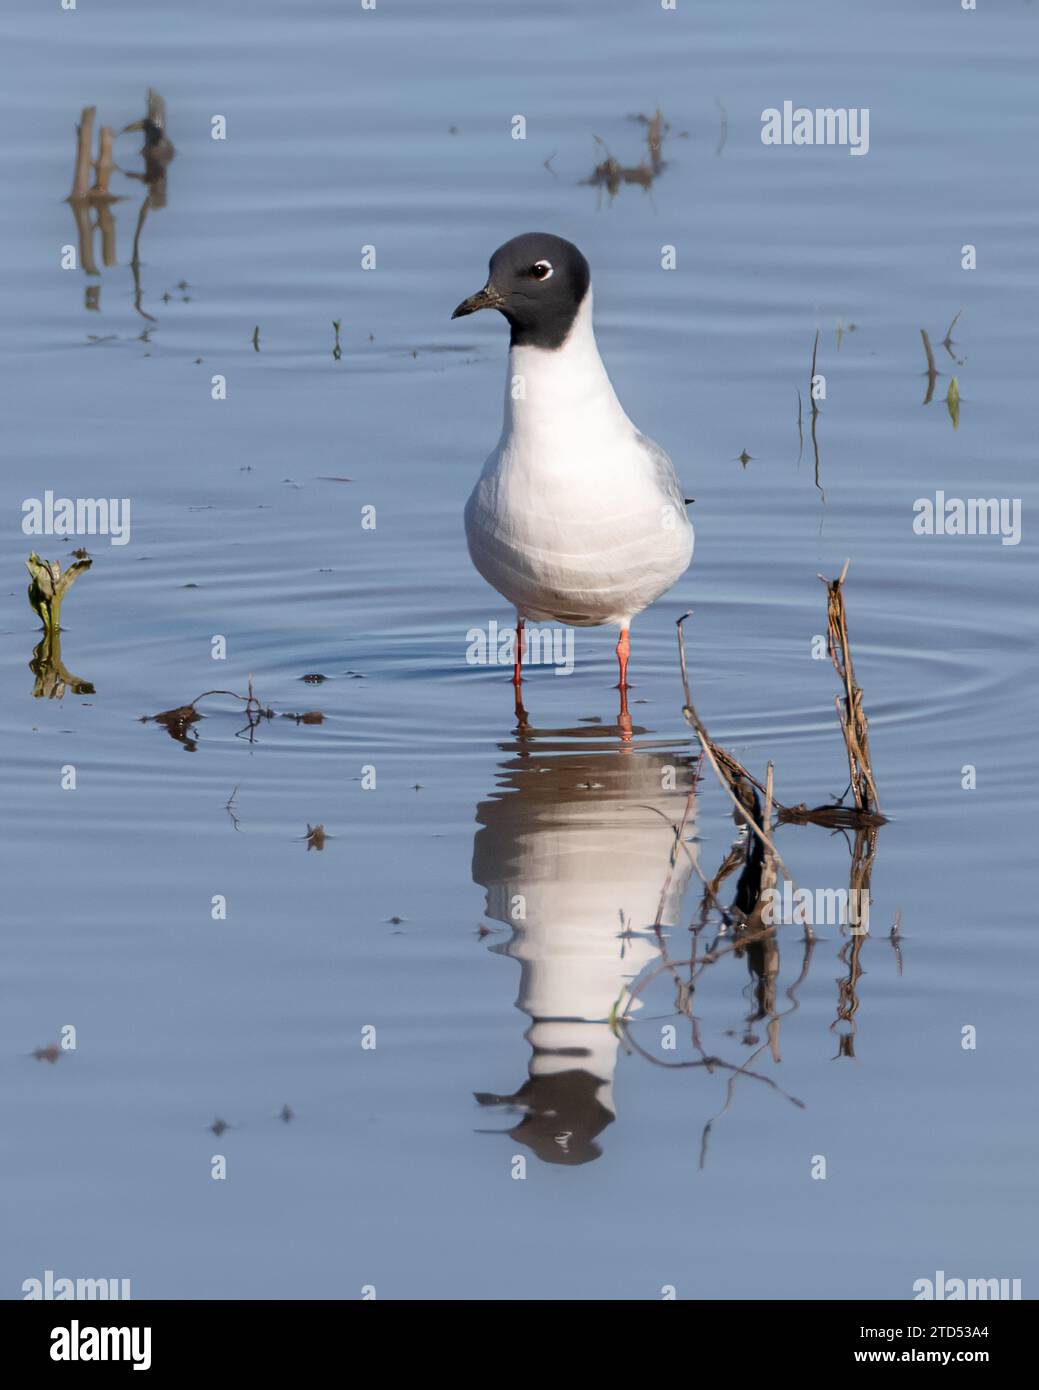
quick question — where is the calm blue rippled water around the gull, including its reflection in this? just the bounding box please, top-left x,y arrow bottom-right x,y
0,0 -> 1039,1298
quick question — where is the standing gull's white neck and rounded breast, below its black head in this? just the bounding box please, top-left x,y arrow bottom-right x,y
466,292 -> 693,626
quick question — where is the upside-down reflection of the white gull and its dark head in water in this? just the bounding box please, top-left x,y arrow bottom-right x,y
473,726 -> 694,1163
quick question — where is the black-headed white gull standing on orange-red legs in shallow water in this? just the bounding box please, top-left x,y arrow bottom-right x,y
451,232 -> 693,714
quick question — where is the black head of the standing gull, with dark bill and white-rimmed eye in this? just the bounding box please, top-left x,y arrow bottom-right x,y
451,232 -> 591,348
